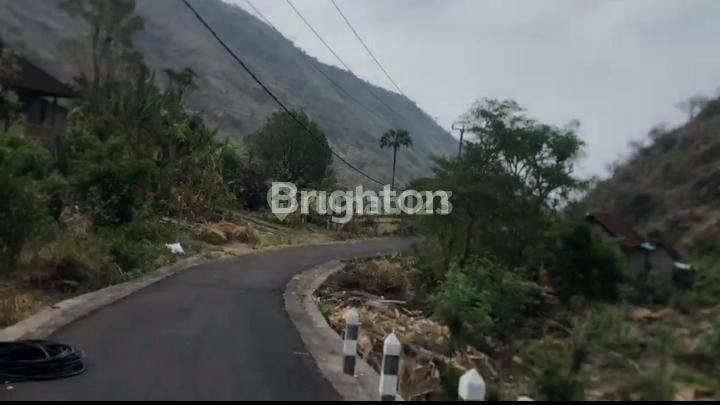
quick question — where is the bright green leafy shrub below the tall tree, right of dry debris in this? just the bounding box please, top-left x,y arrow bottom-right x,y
435,259 -> 540,347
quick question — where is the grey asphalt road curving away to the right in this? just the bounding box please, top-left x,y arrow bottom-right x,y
0,240 -> 411,400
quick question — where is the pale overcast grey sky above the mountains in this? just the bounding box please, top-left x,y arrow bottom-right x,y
226,0 -> 720,175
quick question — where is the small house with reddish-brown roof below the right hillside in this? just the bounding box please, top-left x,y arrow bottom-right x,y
585,212 -> 693,290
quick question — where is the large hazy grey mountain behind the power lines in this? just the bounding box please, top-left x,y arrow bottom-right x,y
0,0 -> 457,184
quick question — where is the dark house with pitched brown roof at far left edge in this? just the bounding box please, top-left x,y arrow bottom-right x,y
0,42 -> 76,151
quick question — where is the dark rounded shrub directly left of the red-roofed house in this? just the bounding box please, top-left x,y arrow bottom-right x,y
547,224 -> 628,301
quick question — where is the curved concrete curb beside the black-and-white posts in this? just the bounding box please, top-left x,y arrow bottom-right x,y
283,260 -> 402,401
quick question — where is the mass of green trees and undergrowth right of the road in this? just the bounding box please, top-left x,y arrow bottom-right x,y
400,96 -> 720,400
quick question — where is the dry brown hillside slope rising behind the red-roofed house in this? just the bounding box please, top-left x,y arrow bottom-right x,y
580,99 -> 720,252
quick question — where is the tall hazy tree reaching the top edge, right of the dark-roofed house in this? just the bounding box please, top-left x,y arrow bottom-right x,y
62,0 -> 144,105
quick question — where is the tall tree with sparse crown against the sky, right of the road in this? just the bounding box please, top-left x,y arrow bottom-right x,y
413,100 -> 584,267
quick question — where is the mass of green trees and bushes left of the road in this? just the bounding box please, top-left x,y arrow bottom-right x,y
0,0 -> 333,291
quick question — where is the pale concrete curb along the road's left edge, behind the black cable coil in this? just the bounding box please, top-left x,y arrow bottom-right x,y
0,257 -> 210,342
